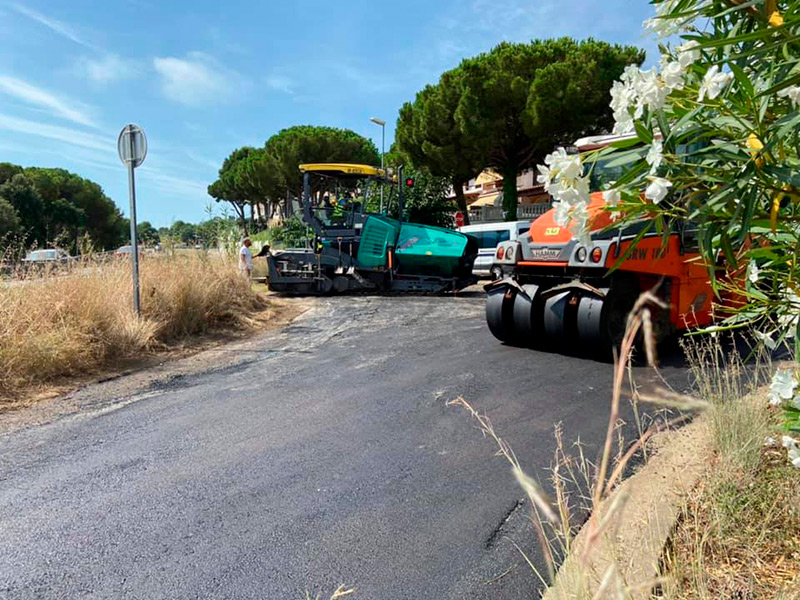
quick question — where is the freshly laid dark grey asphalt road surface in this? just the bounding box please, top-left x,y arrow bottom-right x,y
0,294 -> 687,600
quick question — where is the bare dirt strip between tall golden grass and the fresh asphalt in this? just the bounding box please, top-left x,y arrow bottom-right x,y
0,295 -> 314,433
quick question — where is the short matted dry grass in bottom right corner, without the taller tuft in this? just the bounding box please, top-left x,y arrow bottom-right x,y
657,456 -> 800,600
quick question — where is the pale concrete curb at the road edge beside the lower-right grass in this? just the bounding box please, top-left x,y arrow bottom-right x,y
542,418 -> 710,600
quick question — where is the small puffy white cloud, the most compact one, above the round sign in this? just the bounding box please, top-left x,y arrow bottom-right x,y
153,52 -> 245,106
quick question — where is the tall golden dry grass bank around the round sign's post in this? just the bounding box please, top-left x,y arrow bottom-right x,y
0,253 -> 266,404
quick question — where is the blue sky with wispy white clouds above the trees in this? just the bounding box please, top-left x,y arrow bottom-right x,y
0,0 -> 655,226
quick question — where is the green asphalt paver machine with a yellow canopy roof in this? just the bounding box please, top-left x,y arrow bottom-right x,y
267,163 -> 478,295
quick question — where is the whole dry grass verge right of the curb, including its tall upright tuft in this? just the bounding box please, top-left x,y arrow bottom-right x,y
657,342 -> 800,600
